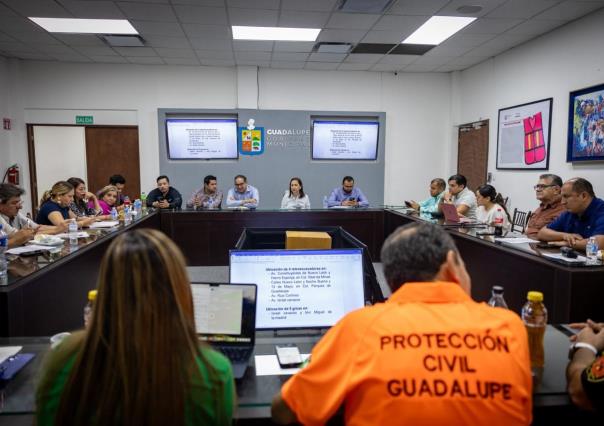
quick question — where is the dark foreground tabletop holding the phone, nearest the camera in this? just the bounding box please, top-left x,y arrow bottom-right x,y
0,325 -> 572,425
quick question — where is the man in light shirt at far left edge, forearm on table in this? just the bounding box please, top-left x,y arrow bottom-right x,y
0,183 -> 67,248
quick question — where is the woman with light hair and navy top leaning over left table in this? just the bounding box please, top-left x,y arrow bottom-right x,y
36,181 -> 96,230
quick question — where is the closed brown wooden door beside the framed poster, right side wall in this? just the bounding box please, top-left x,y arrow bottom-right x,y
457,120 -> 489,191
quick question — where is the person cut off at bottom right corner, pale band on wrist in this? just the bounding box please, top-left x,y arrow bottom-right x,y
566,320 -> 604,412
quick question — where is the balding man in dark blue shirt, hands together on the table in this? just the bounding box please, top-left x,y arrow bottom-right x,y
537,178 -> 604,250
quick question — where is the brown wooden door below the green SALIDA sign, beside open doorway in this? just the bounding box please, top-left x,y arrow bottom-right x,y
86,126 -> 141,200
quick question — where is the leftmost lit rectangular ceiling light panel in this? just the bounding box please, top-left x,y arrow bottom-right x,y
29,17 -> 138,34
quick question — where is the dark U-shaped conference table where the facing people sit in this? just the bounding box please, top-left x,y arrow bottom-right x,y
0,208 -> 604,337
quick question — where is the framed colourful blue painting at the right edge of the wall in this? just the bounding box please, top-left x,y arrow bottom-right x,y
566,84 -> 604,163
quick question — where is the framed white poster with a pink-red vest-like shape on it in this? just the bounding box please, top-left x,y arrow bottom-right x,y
496,98 -> 553,170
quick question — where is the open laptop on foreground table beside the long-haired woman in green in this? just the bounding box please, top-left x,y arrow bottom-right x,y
191,282 -> 257,379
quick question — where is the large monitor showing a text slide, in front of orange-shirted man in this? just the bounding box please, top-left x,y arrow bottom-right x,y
230,248 -> 365,329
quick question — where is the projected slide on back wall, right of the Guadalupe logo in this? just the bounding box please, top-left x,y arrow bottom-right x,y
312,121 -> 379,160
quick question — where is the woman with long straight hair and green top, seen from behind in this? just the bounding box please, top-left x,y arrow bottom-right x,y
36,229 -> 235,426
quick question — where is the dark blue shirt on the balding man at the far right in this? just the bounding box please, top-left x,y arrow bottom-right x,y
547,198 -> 604,238
